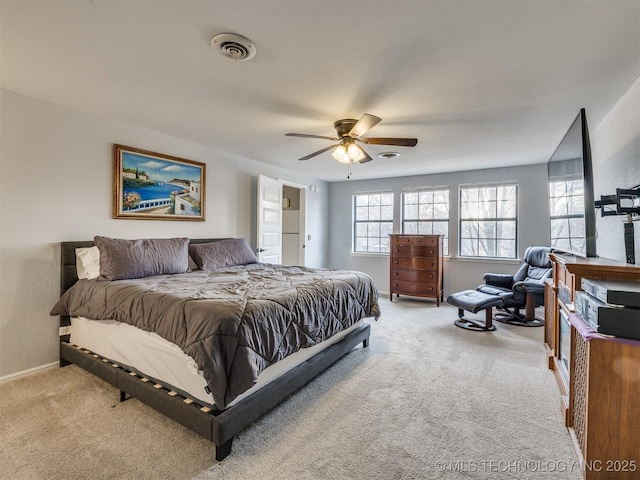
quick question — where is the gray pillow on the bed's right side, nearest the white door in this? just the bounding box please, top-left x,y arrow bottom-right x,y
189,238 -> 258,270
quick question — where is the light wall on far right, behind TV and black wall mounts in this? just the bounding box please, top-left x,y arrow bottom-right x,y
587,78 -> 640,265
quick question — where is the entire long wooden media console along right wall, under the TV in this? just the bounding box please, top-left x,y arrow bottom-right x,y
544,253 -> 640,480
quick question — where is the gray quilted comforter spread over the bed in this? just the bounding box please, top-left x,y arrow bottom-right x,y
51,264 -> 380,409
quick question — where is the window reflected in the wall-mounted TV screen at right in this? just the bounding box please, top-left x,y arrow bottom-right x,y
549,179 -> 586,252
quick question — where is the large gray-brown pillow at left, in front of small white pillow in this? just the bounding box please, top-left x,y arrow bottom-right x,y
93,237 -> 189,280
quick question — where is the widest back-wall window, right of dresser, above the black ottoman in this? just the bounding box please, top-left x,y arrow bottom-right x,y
459,184 -> 518,258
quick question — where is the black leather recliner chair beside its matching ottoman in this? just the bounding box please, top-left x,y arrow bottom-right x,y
477,247 -> 553,327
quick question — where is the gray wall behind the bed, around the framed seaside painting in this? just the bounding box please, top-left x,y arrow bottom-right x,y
0,90 -> 328,380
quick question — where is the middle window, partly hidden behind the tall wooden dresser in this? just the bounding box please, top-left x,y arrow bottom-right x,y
402,188 -> 449,255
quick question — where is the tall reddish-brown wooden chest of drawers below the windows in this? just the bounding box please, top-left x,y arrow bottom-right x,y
389,234 -> 443,306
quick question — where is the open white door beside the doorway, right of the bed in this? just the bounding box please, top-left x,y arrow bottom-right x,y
257,175 -> 282,264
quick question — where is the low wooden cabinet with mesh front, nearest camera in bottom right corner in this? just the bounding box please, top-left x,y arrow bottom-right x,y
569,315 -> 640,480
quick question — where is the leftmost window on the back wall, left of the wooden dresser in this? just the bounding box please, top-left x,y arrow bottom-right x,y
353,192 -> 393,253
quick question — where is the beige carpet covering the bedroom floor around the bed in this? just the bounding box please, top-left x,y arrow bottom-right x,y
0,298 -> 581,480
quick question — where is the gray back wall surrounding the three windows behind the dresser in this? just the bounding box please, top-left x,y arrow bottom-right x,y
329,163 -> 549,297
